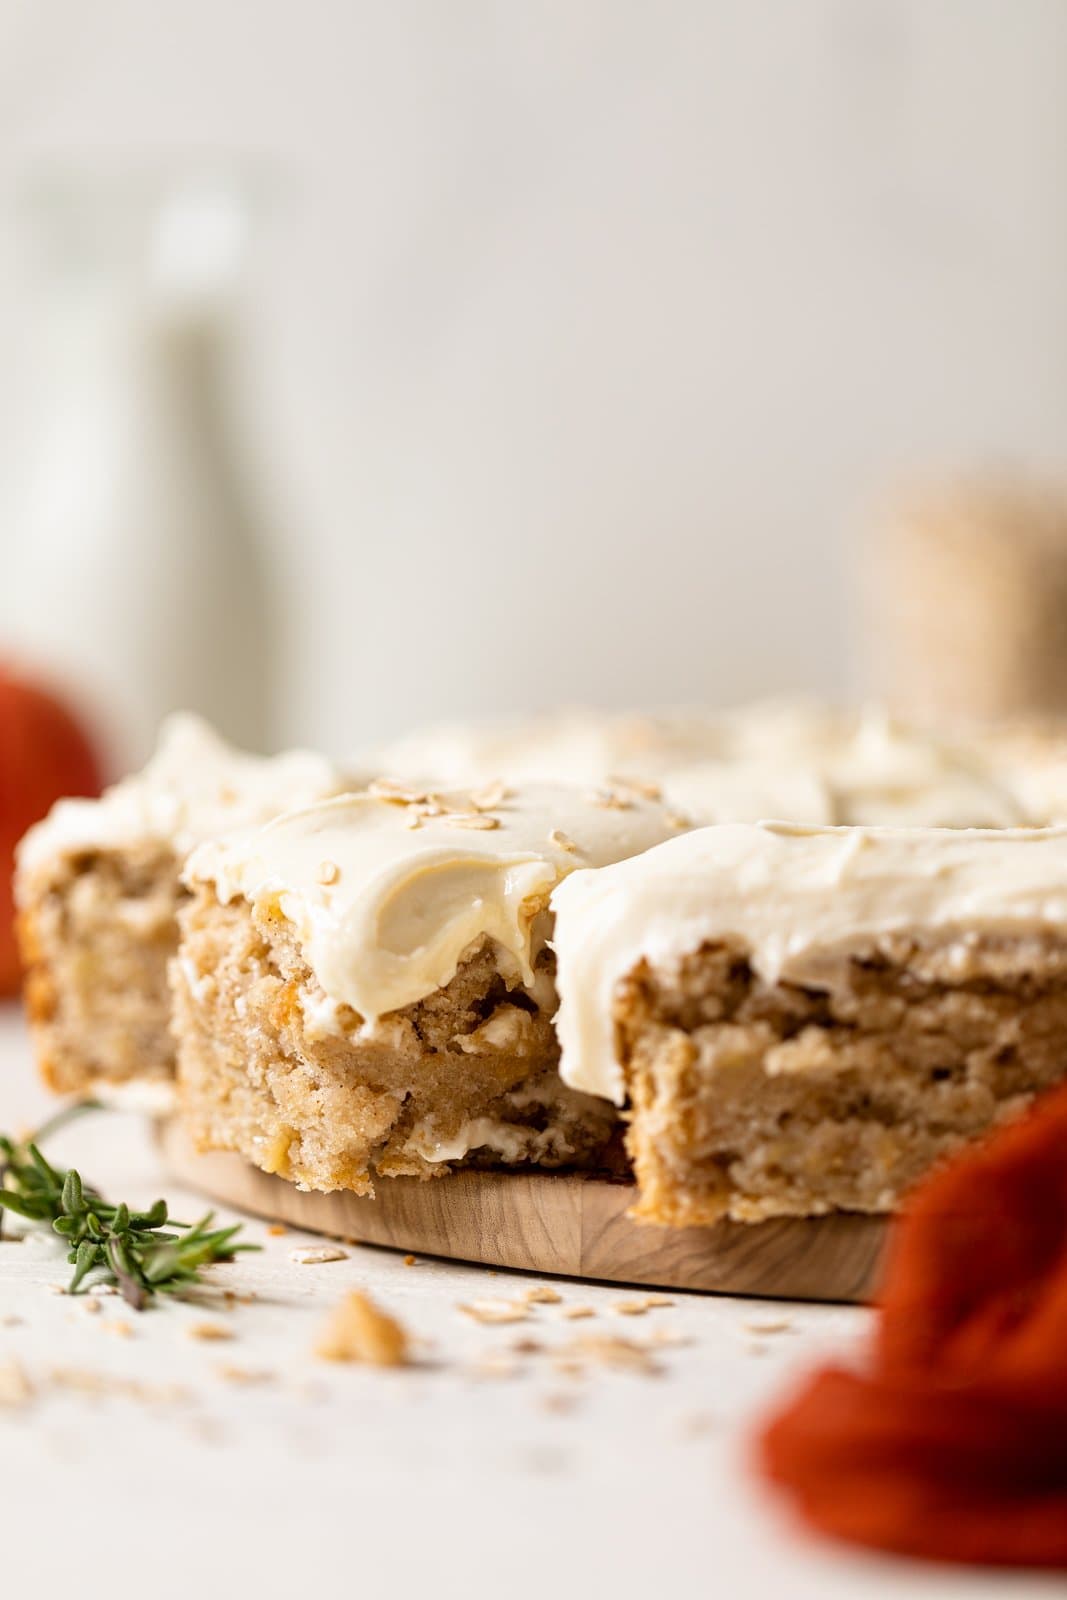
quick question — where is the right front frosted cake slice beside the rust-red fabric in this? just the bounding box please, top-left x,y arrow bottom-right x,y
553,822 -> 1067,1224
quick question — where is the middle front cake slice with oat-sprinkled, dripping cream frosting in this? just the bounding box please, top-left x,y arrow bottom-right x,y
171,784 -> 680,1194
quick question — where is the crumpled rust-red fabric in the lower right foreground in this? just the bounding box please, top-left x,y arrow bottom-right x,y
760,1088 -> 1067,1568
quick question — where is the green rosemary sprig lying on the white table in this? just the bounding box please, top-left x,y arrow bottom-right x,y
0,1101 -> 259,1310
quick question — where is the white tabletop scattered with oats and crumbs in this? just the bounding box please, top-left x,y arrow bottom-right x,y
0,1011 -> 1064,1600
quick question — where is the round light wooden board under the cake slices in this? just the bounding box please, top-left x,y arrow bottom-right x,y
158,1122 -> 886,1301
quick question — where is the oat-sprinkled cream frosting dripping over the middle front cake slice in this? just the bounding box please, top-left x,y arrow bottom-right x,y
186,784 -> 683,1024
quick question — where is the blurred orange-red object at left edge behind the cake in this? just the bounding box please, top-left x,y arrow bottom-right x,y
0,666 -> 101,995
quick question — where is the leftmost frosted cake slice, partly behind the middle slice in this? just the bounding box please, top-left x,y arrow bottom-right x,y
16,714 -> 346,1093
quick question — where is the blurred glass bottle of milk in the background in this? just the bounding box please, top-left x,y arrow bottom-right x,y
0,176 -> 277,768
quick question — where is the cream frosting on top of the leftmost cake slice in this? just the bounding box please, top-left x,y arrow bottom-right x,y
18,712 -> 352,872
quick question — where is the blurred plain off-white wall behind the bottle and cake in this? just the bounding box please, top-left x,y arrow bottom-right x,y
0,0 -> 1067,750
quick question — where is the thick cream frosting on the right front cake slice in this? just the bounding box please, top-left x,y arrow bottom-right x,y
552,822 -> 1067,1104
